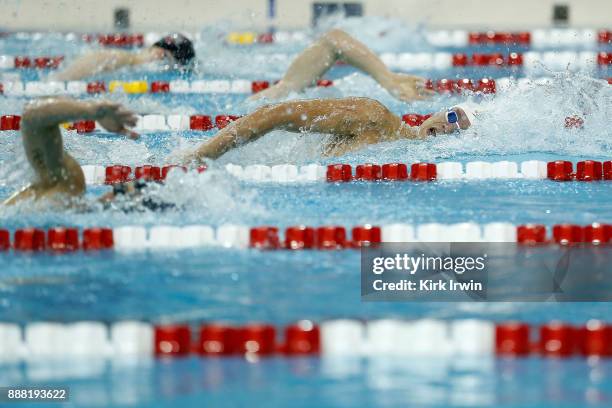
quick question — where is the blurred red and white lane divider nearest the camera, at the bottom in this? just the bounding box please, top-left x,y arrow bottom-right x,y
0,318 -> 612,362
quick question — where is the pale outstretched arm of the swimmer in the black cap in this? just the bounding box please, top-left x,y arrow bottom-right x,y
52,47 -> 163,81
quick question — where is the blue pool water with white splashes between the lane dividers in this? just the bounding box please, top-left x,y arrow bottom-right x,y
0,22 -> 612,407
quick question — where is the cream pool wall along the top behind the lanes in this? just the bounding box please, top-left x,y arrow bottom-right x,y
0,0 -> 612,32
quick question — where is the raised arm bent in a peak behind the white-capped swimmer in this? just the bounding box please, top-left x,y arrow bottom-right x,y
246,29 -> 433,101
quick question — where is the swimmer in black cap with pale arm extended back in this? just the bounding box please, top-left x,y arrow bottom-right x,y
53,33 -> 195,81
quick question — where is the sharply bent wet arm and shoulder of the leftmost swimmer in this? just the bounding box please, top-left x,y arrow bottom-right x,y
3,97 -> 138,205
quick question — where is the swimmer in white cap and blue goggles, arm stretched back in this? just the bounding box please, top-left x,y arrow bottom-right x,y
183,97 -> 474,164
